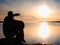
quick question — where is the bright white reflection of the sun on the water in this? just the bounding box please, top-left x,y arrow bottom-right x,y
38,22 -> 50,39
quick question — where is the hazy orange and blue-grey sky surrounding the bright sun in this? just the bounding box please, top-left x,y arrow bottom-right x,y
0,0 -> 60,22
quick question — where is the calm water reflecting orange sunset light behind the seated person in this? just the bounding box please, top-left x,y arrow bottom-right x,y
0,22 -> 60,43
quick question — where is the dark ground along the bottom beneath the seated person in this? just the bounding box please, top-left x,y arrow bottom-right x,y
0,38 -> 52,45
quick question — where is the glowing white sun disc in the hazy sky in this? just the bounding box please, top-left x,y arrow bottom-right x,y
37,5 -> 52,17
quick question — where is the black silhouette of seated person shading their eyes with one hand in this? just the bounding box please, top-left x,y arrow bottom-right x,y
3,11 -> 25,42
